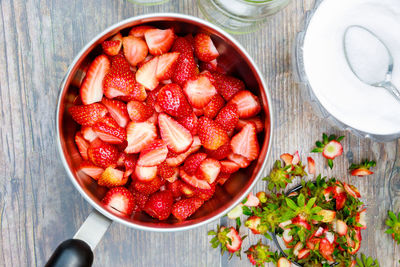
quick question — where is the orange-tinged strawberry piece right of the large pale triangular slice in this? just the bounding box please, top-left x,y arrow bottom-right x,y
198,117 -> 229,150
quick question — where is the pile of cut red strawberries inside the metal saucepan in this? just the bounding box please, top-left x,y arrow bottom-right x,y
68,25 -> 264,222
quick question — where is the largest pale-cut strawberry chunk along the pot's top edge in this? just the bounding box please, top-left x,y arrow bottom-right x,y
144,29 -> 175,56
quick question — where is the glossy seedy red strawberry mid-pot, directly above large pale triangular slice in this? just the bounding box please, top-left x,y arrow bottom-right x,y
157,83 -> 192,118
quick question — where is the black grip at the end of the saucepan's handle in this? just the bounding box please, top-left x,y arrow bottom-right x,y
45,239 -> 93,267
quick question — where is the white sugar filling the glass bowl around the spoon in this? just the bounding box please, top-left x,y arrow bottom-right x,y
303,0 -> 400,135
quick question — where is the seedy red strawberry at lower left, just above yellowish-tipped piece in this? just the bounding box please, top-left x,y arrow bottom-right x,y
88,139 -> 119,169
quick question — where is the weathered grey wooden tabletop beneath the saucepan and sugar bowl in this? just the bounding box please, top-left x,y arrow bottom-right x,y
0,0 -> 400,267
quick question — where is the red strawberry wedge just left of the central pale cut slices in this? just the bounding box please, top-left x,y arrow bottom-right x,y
92,118 -> 126,144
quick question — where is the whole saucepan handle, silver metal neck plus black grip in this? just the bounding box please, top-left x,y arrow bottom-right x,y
45,210 -> 112,267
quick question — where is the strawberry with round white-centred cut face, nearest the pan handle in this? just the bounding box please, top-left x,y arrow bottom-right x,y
101,187 -> 135,216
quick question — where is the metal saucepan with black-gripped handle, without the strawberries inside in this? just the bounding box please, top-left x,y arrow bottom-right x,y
46,13 -> 273,266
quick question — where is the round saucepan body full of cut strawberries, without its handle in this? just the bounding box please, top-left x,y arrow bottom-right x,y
56,14 -> 272,237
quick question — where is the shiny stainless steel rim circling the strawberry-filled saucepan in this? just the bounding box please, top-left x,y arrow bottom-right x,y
55,13 -> 274,232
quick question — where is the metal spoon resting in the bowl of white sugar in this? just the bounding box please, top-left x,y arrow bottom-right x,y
343,25 -> 400,102
